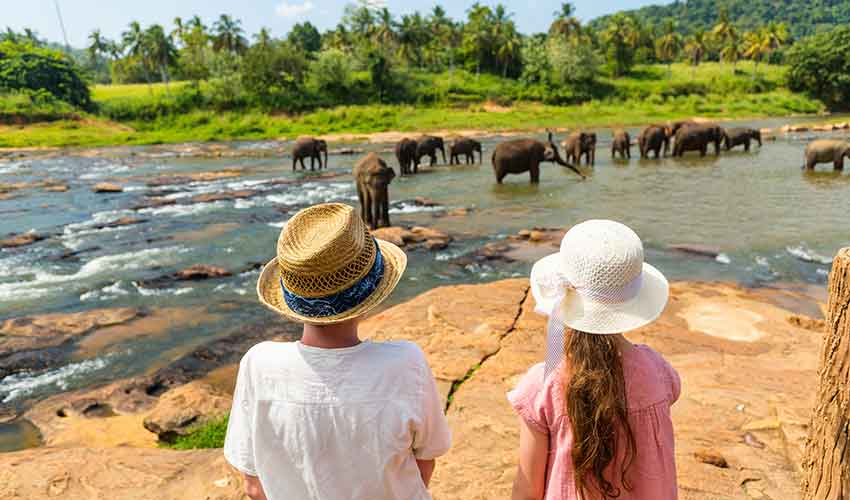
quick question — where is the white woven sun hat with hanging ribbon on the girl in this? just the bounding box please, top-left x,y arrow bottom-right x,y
531,220 -> 670,373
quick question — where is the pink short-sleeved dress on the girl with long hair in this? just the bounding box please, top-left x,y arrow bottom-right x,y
508,345 -> 681,500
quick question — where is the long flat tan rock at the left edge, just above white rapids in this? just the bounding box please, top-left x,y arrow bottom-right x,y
0,307 -> 141,356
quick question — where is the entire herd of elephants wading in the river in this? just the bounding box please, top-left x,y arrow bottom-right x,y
292,121 -> 850,229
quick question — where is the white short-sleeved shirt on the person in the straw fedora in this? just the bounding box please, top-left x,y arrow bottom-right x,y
224,341 -> 451,500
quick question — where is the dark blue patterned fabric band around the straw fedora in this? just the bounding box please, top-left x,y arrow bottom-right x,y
280,238 -> 384,318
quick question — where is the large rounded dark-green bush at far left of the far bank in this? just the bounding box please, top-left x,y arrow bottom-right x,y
0,41 -> 91,109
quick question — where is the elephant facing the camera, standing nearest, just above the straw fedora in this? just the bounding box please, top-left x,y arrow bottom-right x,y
352,153 -> 395,229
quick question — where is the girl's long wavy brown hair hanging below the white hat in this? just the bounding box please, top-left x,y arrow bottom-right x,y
564,330 -> 637,499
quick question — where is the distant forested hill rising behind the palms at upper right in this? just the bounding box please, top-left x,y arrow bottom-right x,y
590,0 -> 850,38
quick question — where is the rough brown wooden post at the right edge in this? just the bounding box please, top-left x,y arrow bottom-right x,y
803,248 -> 850,500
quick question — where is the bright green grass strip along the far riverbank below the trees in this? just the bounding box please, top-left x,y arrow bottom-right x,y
0,62 -> 825,148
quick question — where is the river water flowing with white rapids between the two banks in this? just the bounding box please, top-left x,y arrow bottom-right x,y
0,116 -> 850,449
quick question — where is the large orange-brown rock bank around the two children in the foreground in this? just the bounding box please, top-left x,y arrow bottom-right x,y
0,279 -> 823,500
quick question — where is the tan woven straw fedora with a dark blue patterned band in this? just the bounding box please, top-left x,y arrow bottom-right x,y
257,203 -> 407,325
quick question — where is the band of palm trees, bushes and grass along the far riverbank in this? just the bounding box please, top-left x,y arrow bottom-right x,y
0,0 -> 847,147
